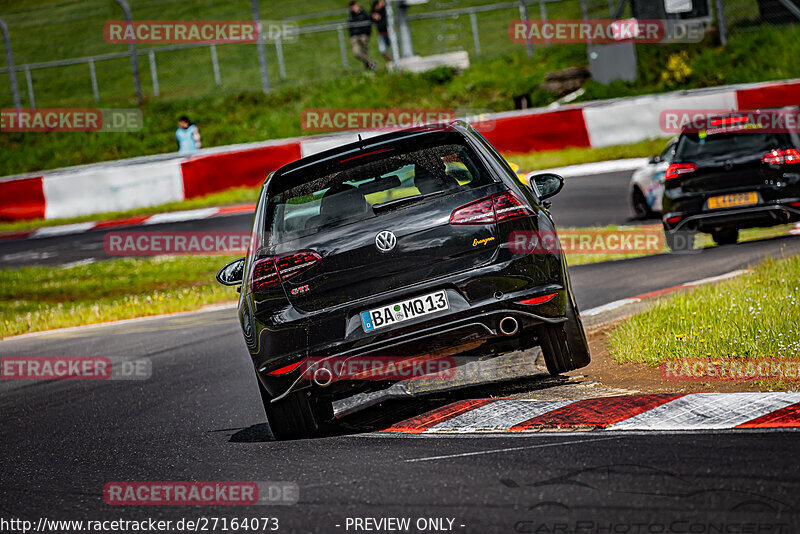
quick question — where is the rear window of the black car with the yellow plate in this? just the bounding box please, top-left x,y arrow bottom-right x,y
675,131 -> 789,159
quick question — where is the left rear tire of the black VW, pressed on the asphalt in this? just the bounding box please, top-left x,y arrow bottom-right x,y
258,383 -> 333,440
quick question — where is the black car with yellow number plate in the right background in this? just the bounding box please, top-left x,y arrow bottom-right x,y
662,109 -> 800,250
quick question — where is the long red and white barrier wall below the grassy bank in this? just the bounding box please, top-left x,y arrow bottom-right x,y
0,80 -> 800,220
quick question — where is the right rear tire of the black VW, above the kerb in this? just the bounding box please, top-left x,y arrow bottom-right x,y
539,298 -> 591,375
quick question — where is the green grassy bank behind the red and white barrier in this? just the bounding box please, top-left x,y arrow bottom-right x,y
0,0 -> 800,175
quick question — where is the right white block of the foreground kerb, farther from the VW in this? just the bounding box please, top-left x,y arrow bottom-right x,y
607,392 -> 800,430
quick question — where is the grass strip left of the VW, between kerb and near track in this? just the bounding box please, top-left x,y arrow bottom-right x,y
0,256 -> 237,338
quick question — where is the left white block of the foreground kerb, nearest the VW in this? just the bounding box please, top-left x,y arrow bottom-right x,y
425,399 -> 577,433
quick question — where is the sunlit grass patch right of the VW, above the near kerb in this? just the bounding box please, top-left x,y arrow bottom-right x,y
609,256 -> 800,365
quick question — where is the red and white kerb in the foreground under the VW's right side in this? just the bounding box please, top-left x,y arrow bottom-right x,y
381,392 -> 800,434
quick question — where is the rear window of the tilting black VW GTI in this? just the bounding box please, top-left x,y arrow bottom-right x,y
266,140 -> 493,243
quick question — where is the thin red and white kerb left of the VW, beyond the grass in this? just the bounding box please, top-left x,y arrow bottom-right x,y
0,204 -> 256,240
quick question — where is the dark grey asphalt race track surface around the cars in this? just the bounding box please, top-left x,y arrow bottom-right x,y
0,168 -> 800,534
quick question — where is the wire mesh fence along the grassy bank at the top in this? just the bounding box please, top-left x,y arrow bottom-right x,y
0,0 -> 800,108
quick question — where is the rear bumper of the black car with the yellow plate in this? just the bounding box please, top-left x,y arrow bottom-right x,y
663,198 -> 800,232
